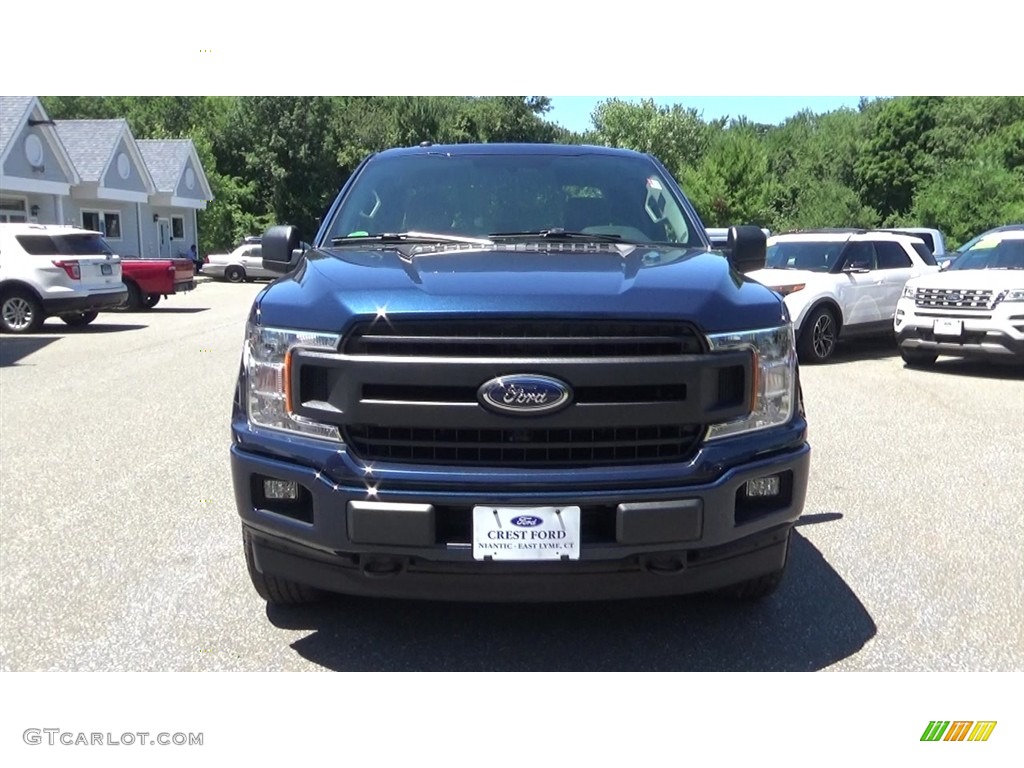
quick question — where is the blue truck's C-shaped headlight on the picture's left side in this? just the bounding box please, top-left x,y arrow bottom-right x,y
243,324 -> 341,440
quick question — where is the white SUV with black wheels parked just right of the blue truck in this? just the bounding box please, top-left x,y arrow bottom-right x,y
748,229 -> 939,362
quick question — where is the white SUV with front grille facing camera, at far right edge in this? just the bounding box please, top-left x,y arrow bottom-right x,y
894,229 -> 1024,366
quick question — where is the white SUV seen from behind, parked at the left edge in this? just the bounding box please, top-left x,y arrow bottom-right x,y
0,223 -> 128,334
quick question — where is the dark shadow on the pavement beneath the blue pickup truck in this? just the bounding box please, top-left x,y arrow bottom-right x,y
267,532 -> 877,672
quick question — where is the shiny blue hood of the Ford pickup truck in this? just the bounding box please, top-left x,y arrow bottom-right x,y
257,243 -> 784,331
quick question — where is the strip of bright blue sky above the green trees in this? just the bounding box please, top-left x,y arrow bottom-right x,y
546,96 -> 872,132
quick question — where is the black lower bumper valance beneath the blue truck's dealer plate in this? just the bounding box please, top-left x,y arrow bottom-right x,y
247,524 -> 792,602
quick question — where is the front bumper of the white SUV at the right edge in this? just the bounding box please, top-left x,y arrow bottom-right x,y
894,299 -> 1024,362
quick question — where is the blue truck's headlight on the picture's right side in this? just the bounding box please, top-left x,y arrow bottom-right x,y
708,325 -> 797,440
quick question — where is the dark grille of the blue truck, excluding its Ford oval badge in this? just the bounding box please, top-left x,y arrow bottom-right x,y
292,318 -> 754,468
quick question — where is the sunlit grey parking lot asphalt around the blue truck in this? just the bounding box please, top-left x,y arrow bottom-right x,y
0,282 -> 1024,671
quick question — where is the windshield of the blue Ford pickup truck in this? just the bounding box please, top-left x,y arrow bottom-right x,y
327,154 -> 705,248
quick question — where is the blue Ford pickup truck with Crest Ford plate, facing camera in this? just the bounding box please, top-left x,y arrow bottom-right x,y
230,142 -> 810,603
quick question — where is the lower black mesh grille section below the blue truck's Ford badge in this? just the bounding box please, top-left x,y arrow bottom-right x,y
343,424 -> 703,467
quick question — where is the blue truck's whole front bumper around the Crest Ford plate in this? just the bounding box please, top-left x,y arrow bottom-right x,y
231,443 -> 810,601
